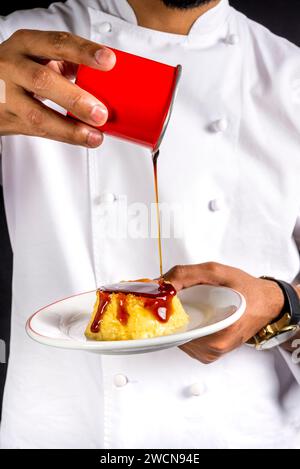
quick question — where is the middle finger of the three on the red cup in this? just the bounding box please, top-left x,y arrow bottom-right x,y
12,58 -> 108,126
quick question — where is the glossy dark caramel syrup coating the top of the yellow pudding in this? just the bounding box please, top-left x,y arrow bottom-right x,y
91,280 -> 176,333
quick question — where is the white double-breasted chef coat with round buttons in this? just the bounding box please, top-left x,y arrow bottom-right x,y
0,0 -> 300,448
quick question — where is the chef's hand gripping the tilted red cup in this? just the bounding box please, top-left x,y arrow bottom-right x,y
0,30 -> 116,147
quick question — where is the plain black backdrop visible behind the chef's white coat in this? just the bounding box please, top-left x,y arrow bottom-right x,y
0,0 -> 300,416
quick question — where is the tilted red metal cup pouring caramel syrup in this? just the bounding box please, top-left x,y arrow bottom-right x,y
69,49 -> 182,152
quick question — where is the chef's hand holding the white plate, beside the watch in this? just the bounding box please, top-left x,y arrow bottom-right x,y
164,262 -> 284,364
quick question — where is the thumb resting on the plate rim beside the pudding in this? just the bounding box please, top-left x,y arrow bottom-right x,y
164,262 -> 232,290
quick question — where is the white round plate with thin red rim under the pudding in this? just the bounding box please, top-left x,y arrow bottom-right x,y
26,285 -> 246,355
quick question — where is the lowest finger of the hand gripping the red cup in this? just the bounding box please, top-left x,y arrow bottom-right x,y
8,90 -> 103,148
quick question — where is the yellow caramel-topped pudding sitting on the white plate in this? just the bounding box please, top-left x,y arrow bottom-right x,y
85,280 -> 188,340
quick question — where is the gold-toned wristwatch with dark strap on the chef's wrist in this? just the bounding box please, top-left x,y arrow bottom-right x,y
247,277 -> 300,350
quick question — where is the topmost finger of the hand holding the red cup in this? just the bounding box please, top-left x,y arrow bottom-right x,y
12,29 -> 116,71
